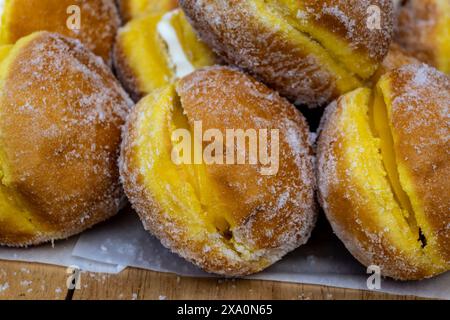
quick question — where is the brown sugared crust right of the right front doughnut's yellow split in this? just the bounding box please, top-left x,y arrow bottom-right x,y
388,65 -> 450,264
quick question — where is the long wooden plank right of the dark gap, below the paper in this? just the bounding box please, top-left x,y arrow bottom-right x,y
73,269 -> 417,300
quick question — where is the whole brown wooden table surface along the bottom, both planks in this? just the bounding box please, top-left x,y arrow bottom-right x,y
0,261 -> 418,300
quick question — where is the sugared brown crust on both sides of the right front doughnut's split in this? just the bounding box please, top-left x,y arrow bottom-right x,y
317,64 -> 450,280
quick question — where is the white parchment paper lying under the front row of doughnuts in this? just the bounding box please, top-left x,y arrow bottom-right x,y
0,210 -> 450,299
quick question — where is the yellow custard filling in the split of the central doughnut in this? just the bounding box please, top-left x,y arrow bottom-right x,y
133,85 -> 234,241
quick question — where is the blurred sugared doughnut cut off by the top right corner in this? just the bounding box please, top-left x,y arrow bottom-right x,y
395,0 -> 450,74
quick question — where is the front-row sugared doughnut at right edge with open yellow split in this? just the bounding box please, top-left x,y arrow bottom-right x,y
318,64 -> 450,280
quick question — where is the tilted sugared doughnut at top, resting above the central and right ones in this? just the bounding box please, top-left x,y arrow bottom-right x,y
179,0 -> 393,107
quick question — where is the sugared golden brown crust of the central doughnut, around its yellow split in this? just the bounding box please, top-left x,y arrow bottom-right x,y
120,67 -> 316,276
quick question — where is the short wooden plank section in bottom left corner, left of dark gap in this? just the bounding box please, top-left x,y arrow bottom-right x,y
0,261 -> 68,300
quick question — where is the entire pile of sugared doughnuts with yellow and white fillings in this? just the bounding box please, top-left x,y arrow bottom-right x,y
0,0 -> 450,280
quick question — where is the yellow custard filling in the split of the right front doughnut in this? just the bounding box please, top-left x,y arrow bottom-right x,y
338,84 -> 445,268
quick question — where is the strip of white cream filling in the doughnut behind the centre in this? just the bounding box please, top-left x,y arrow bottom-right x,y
157,10 -> 195,78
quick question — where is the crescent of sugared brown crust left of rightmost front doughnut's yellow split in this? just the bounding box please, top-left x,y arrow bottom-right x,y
317,98 -> 427,279
